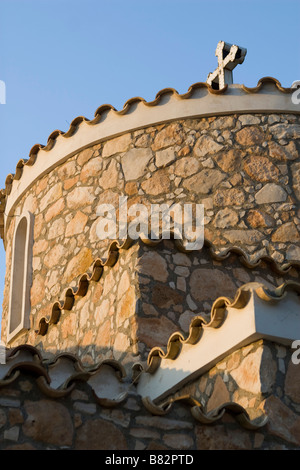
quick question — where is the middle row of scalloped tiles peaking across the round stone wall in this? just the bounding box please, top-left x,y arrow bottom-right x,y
36,238 -> 300,341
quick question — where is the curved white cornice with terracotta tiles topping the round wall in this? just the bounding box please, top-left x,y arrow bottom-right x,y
0,77 -> 300,242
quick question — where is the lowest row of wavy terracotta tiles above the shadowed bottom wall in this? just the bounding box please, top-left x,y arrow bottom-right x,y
0,344 -> 268,430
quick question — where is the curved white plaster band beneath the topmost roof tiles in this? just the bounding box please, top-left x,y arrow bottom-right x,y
4,83 -> 300,229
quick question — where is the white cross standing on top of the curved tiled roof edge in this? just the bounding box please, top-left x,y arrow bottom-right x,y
206,41 -> 247,90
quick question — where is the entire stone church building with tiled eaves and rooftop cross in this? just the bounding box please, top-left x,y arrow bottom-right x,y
0,42 -> 300,451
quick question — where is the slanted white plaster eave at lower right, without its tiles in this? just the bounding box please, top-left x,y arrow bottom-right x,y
137,291 -> 300,401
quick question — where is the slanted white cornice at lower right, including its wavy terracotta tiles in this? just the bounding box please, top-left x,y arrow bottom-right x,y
137,281 -> 300,402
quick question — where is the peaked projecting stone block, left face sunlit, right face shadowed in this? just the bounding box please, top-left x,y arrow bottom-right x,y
15,240 -> 299,370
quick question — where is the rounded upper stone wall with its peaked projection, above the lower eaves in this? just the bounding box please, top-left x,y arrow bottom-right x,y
2,115 -> 300,370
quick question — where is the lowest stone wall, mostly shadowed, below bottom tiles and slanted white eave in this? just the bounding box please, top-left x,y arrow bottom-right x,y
0,341 -> 300,451
